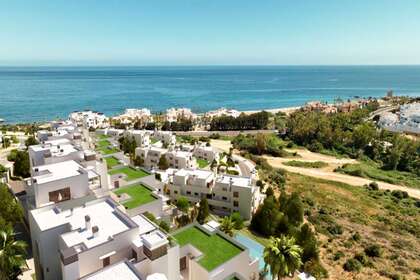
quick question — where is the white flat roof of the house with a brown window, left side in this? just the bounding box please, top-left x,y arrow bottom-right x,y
32,160 -> 84,184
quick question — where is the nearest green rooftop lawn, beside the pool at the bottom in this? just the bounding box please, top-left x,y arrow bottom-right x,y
173,226 -> 242,271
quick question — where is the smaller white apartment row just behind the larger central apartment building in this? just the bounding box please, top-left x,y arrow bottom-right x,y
135,146 -> 196,169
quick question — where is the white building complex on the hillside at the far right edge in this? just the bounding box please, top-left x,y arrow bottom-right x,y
378,103 -> 420,134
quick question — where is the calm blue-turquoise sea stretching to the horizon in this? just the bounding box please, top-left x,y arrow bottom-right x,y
0,66 -> 420,123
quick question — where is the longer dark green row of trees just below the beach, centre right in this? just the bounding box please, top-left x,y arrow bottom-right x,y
210,111 -> 269,130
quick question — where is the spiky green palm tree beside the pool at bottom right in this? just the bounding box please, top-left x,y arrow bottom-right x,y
264,235 -> 303,280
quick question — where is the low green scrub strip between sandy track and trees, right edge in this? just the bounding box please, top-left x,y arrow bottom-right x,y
336,162 -> 420,188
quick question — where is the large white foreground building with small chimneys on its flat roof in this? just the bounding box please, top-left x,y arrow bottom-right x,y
29,198 -> 180,280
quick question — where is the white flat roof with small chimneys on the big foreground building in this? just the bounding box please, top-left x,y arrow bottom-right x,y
32,200 -> 134,248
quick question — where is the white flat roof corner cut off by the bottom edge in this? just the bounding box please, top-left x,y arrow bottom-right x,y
81,262 -> 141,280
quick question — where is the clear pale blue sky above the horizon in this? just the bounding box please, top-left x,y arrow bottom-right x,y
0,0 -> 420,65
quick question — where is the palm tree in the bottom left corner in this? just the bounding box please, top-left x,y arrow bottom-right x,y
0,227 -> 26,279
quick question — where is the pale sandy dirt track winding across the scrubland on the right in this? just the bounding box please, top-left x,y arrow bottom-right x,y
264,149 -> 420,199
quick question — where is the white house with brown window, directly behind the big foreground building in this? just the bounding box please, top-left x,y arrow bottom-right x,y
26,160 -> 107,209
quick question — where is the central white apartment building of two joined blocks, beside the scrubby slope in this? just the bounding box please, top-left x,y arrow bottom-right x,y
168,169 -> 264,219
